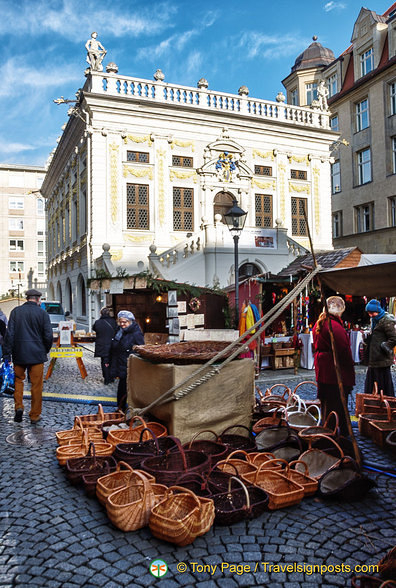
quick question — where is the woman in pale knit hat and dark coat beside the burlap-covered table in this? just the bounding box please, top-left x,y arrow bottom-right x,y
111,310 -> 144,412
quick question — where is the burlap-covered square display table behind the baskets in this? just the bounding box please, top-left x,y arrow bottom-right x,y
127,355 -> 255,443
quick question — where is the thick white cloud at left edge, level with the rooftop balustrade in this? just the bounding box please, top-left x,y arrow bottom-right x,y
0,57 -> 81,98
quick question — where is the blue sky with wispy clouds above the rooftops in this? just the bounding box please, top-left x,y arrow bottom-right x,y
0,0 -> 392,165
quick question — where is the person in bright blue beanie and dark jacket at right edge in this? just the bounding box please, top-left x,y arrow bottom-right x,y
364,298 -> 396,396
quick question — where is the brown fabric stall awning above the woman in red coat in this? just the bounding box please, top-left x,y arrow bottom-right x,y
319,261 -> 396,298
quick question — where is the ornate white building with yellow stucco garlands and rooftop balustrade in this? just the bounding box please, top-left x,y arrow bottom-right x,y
42,52 -> 337,327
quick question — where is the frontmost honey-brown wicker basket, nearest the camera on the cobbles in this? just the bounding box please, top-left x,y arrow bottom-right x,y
149,486 -> 215,547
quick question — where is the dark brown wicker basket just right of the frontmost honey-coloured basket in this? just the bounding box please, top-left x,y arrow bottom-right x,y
213,476 -> 269,525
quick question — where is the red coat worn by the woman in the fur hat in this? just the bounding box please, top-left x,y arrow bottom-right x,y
313,316 -> 355,386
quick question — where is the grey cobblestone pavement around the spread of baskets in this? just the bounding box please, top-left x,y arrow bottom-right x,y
0,352 -> 396,588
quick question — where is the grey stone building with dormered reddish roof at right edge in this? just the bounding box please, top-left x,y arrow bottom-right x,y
284,3 -> 396,253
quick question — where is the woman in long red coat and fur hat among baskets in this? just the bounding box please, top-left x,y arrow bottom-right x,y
312,296 -> 355,437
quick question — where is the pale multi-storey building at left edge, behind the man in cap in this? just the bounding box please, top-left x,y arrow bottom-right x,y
0,164 -> 47,296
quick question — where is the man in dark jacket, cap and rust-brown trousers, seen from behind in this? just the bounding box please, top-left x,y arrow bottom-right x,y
3,289 -> 53,424
